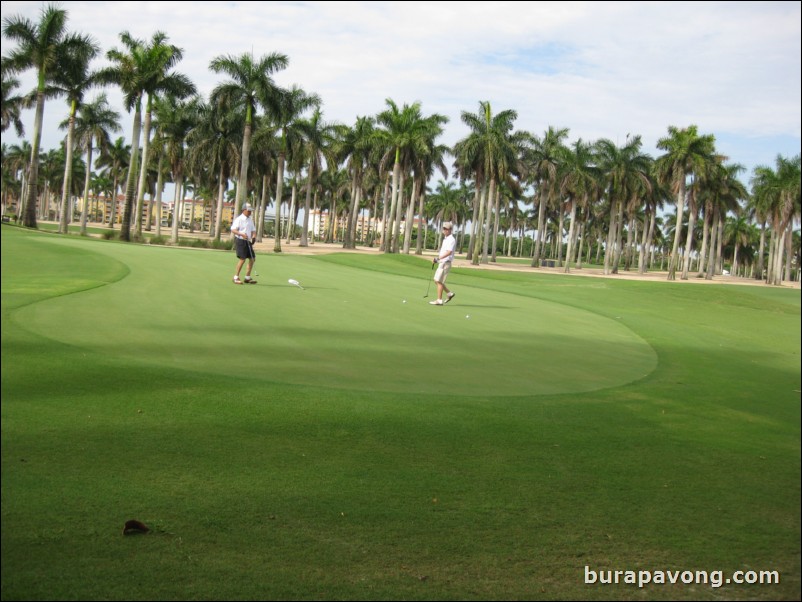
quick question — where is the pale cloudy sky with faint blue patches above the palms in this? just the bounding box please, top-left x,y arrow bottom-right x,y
2,0 -> 802,183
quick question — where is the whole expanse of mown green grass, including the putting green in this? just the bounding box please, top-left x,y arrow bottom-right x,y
2,227 -> 800,600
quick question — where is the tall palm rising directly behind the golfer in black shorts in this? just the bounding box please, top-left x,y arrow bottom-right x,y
209,52 -> 290,220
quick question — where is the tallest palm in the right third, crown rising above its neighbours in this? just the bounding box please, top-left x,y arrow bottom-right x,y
656,125 -> 716,280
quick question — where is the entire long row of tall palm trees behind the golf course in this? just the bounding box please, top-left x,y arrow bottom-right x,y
2,6 -> 800,284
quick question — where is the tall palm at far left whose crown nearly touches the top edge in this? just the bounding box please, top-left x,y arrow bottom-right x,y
3,4 -> 97,228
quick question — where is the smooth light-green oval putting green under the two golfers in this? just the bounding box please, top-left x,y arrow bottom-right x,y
14,236 -> 657,396
